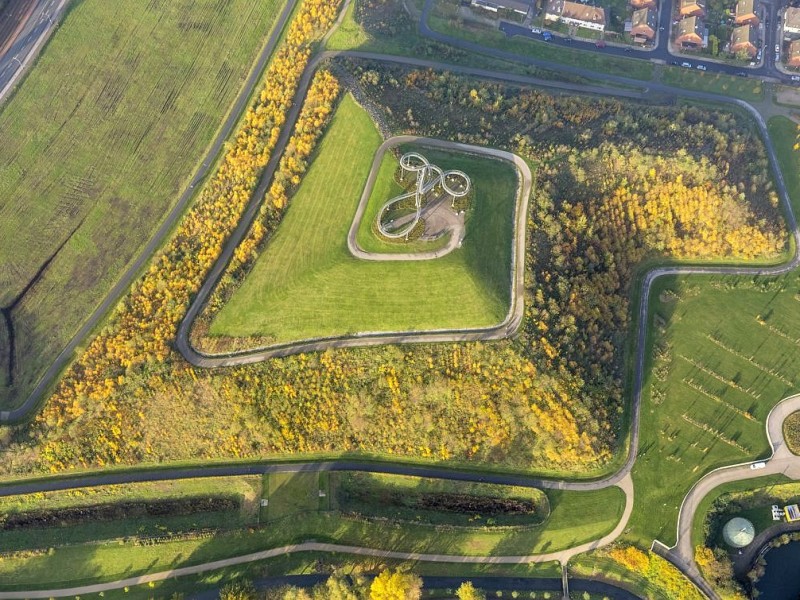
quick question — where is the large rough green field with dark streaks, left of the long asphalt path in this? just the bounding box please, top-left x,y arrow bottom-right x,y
0,0 -> 282,408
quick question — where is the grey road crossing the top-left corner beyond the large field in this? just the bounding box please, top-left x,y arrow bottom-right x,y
0,0 -> 69,104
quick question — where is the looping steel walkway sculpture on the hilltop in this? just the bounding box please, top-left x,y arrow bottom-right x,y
377,152 -> 472,239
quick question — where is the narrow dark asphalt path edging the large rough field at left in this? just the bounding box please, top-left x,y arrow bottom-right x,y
0,0 -> 297,423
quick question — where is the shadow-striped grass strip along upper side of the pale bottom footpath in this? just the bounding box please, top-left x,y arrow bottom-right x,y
0,473 -> 624,589
